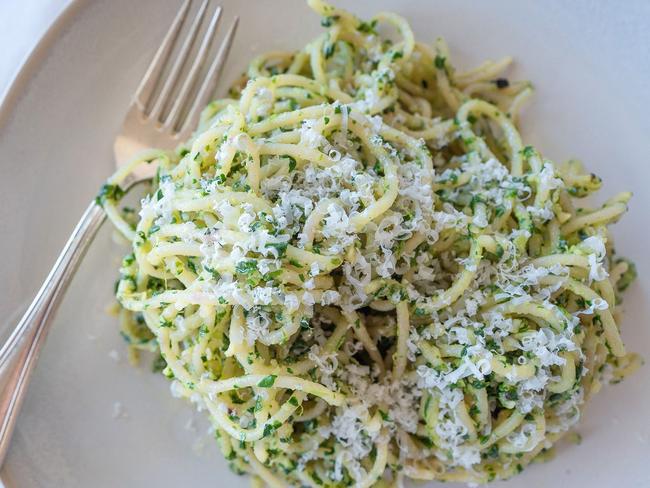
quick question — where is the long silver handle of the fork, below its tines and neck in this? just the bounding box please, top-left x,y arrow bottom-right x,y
0,201 -> 105,466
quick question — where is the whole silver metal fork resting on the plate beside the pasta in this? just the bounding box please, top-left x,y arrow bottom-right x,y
0,0 -> 239,466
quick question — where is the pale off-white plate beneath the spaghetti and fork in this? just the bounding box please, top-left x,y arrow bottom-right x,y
0,0 -> 650,488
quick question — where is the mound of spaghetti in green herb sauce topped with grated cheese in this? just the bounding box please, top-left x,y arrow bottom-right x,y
98,0 -> 640,487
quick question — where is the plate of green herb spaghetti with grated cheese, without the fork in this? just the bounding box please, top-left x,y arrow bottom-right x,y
0,0 -> 650,488
